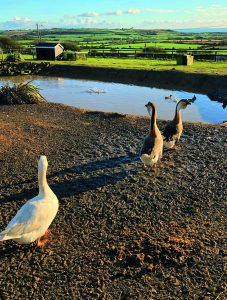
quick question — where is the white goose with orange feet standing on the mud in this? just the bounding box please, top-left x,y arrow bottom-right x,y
0,156 -> 58,247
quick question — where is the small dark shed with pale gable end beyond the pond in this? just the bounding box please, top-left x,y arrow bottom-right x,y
36,42 -> 64,60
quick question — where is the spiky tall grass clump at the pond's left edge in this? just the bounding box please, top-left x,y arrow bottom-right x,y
0,82 -> 46,105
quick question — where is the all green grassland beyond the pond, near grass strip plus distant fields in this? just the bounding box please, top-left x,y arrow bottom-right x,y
0,29 -> 227,75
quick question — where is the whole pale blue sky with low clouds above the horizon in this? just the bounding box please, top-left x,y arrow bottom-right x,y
0,0 -> 227,30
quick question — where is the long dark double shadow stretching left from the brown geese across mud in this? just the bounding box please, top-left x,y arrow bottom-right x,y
0,153 -> 139,203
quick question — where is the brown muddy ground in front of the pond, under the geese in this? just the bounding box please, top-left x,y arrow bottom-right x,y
0,104 -> 227,300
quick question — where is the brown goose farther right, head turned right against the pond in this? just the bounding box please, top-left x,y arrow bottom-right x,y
163,97 -> 194,149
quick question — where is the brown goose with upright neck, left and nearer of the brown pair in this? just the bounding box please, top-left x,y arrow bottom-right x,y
140,102 -> 163,167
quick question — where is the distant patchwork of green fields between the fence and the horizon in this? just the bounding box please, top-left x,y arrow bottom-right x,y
0,29 -> 227,50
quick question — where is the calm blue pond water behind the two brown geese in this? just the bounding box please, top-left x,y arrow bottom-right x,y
0,76 -> 227,123
